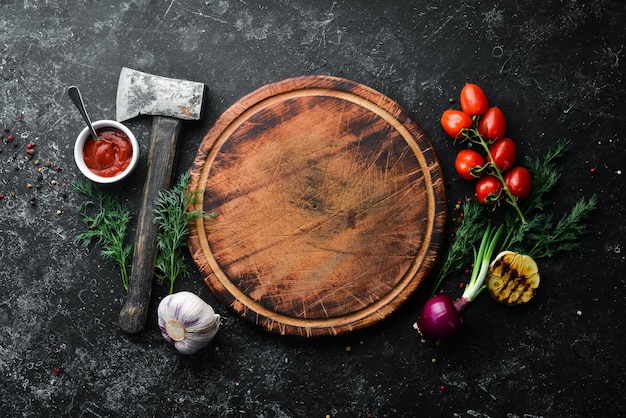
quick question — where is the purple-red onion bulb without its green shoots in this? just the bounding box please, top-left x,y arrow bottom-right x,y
413,294 -> 467,339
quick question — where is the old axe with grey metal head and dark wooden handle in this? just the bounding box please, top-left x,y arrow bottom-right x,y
115,67 -> 204,333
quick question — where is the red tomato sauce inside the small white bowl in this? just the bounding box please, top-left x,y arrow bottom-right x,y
83,128 -> 133,177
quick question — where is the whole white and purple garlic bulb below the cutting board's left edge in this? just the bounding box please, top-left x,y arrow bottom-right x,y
158,292 -> 220,354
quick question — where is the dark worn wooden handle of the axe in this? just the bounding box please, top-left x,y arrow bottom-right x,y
119,116 -> 181,333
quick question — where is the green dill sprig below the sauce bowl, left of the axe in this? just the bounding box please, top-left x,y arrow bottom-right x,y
73,180 -> 132,292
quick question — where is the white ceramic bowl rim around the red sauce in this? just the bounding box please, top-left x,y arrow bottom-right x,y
74,120 -> 139,183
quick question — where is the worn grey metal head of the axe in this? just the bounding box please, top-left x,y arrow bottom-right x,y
115,67 -> 204,122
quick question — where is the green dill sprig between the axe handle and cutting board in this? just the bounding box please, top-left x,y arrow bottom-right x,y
154,172 -> 215,294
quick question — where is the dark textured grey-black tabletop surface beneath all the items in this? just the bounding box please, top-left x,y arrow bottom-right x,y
0,0 -> 626,417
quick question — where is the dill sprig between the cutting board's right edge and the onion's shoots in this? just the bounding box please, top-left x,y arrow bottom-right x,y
431,199 -> 487,297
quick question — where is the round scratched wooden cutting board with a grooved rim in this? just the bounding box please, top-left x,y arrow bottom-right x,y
189,76 -> 445,337
